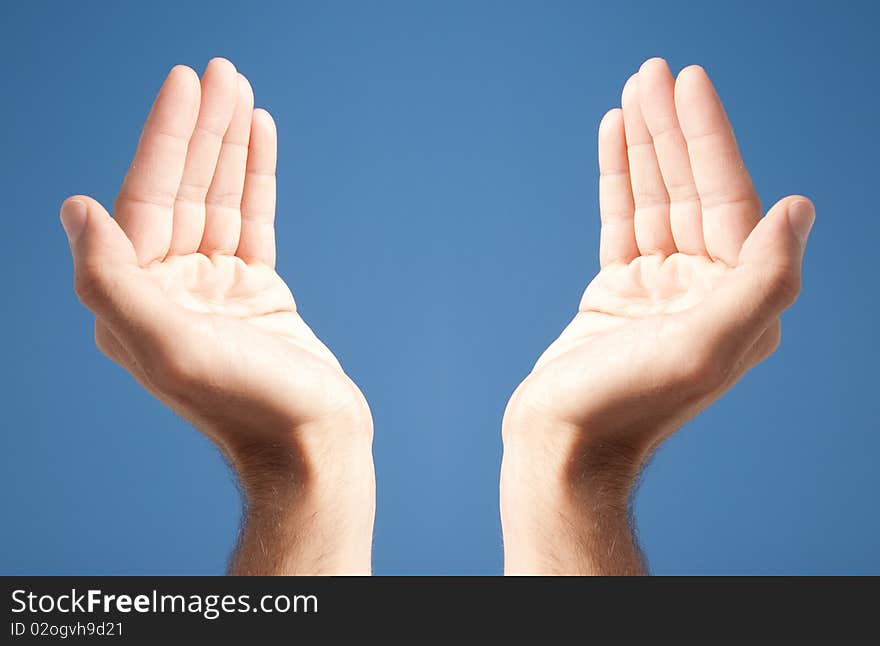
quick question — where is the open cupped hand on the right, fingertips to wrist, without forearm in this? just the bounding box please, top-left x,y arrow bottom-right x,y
506,59 -> 813,450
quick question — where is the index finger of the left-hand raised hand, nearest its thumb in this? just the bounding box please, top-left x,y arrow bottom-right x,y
113,65 -> 200,264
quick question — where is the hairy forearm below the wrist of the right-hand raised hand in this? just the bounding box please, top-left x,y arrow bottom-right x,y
501,416 -> 645,575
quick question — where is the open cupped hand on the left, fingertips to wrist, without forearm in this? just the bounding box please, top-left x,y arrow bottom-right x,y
62,59 -> 370,456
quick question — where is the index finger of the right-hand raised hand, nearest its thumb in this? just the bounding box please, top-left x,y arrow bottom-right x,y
675,65 -> 761,264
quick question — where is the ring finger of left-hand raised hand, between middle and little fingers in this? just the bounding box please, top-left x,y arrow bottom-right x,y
199,74 -> 254,256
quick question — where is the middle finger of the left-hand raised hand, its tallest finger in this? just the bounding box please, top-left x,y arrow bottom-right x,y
168,58 -> 238,255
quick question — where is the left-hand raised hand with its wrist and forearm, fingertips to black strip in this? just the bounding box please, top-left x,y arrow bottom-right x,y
61,59 -> 375,574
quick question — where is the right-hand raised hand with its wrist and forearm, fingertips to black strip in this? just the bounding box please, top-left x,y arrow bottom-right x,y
501,58 -> 814,574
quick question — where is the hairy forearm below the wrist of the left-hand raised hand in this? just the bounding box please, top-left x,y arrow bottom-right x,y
222,426 -> 375,575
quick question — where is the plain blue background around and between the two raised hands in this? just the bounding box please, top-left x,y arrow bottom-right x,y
0,1 -> 880,574
